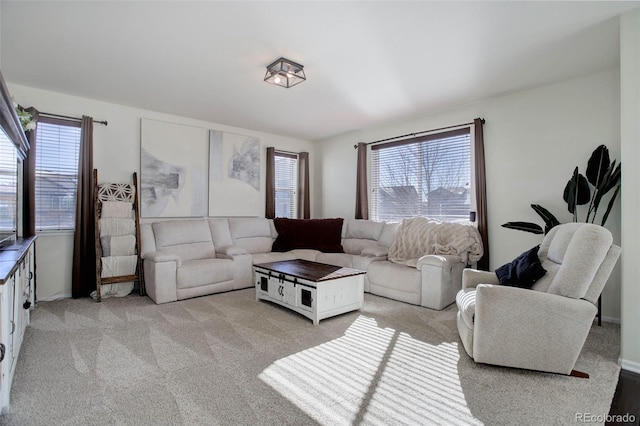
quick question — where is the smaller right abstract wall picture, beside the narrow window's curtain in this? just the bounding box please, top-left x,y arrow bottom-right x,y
209,130 -> 264,216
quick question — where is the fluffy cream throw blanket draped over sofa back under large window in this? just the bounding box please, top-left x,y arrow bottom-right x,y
388,217 -> 483,266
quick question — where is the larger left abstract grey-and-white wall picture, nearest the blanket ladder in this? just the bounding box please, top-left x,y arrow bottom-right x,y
140,118 -> 209,217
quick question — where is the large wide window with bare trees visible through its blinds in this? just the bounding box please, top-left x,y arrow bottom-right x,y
371,128 -> 474,222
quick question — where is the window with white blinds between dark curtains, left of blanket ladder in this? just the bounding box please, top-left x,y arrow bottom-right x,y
35,117 -> 80,231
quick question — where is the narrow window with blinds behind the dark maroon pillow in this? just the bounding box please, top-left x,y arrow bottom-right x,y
275,151 -> 298,219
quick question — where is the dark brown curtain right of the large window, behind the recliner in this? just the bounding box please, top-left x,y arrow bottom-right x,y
473,118 -> 489,271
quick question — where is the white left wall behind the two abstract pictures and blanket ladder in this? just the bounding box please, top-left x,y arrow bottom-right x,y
8,83 -> 314,300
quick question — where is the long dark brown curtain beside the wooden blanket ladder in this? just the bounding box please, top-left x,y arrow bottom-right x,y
71,116 -> 96,299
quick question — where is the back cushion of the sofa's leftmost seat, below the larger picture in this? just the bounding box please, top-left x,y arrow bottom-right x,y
152,219 -> 216,260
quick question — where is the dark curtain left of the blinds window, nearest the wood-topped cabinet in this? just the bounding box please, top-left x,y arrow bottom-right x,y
22,107 -> 40,238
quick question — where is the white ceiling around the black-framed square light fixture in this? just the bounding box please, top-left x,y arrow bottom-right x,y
0,0 -> 640,140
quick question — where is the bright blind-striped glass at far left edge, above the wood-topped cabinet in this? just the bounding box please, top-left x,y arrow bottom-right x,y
0,130 -> 18,235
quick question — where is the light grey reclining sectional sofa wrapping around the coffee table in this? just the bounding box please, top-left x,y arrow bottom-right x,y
141,217 -> 480,309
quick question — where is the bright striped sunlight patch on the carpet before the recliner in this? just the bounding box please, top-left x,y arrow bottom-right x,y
259,315 -> 482,425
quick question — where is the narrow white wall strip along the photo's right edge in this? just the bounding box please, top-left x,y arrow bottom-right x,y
620,9 -> 640,373
